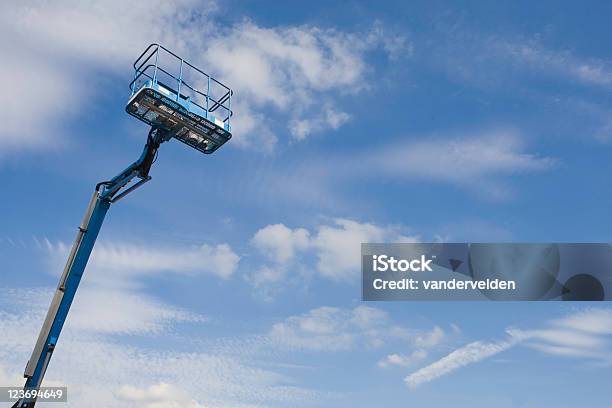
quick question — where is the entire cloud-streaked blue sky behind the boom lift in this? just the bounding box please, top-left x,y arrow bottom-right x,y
0,0 -> 612,408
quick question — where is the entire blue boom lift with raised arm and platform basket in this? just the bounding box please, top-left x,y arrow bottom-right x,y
13,44 -> 233,408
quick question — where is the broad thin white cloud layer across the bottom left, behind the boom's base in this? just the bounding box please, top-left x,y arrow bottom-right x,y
0,288 -> 325,408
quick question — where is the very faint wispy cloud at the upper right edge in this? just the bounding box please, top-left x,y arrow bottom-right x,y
430,24 -> 612,94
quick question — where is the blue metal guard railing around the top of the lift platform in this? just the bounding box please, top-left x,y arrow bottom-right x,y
130,43 -> 233,129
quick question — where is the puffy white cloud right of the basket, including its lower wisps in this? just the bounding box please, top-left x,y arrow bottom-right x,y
207,21 -> 407,145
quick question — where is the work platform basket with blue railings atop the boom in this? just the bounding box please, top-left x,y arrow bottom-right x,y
125,44 -> 233,154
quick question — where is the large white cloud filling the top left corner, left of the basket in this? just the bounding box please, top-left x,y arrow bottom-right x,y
0,0 -> 213,150
